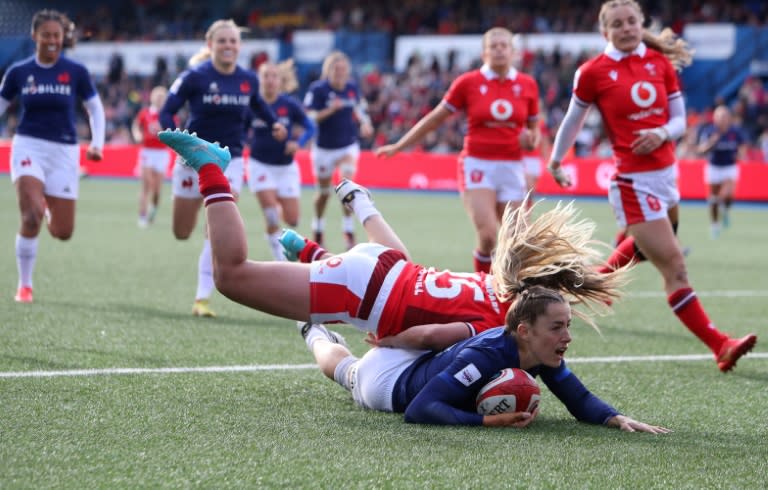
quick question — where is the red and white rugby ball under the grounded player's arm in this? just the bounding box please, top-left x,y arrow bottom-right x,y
476,368 -> 541,415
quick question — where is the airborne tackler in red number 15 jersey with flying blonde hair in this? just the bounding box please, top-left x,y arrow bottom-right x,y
159,131 -> 624,348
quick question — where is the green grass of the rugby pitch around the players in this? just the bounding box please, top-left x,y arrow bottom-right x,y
0,180 -> 768,489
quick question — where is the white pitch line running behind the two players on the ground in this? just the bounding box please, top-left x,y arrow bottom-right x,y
0,352 -> 768,378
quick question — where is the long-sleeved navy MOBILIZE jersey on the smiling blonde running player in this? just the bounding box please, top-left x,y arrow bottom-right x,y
160,60 -> 277,157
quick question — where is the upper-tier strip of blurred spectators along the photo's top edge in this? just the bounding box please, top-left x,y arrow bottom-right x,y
63,0 -> 768,40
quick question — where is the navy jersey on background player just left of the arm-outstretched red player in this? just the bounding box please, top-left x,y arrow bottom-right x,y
304,80 -> 360,150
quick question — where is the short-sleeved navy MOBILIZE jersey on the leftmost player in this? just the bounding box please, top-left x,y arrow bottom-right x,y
0,56 -> 98,144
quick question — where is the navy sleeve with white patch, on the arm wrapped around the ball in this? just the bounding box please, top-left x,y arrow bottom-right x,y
405,348 -> 499,425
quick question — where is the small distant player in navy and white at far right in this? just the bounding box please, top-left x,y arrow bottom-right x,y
696,105 -> 749,239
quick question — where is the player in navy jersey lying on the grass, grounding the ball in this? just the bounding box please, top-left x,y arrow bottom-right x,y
301,286 -> 669,434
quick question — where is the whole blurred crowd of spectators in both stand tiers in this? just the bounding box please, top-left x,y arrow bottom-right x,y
0,0 -> 768,160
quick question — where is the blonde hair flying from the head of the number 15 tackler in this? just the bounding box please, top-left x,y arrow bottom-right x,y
491,202 -> 627,334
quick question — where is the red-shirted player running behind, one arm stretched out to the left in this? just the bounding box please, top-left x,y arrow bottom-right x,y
376,27 -> 540,272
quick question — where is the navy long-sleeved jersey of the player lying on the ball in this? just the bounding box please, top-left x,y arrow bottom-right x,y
392,327 -> 619,425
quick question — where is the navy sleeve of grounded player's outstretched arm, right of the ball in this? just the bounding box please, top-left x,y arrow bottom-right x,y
541,362 -> 619,424
